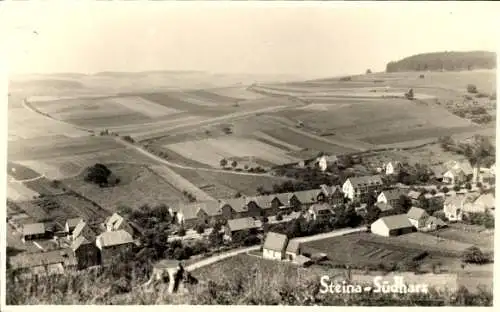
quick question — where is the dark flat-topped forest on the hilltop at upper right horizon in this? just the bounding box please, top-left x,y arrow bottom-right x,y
386,51 -> 496,73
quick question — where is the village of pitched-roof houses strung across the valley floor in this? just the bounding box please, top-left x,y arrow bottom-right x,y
4,145 -> 495,294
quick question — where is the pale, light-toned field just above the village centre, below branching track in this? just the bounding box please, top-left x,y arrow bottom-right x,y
165,138 -> 298,167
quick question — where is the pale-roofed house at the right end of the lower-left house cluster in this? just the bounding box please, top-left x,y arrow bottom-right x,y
95,230 -> 134,265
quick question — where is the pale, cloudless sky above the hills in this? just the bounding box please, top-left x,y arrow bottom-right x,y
0,1 -> 500,77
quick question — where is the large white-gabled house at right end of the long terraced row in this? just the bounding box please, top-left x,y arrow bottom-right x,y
342,175 -> 383,202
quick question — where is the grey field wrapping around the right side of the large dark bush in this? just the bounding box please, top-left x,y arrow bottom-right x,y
62,164 -> 185,212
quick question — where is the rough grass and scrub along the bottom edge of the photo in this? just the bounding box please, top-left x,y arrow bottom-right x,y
7,257 -> 493,306
